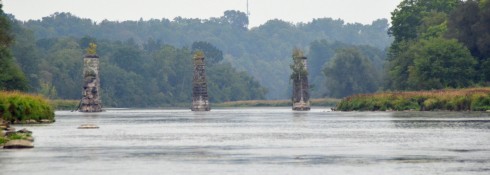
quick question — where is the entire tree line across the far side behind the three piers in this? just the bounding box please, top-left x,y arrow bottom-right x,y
0,0 -> 490,106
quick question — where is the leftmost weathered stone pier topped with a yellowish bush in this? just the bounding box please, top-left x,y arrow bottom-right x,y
79,43 -> 102,112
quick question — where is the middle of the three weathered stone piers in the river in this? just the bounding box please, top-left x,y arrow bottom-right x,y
191,51 -> 211,111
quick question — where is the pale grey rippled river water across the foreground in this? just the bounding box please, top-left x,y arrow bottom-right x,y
0,108 -> 490,175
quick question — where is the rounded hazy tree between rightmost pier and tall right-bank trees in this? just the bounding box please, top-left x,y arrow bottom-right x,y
323,48 -> 379,98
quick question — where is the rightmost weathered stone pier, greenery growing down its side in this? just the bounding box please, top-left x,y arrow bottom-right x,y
291,49 -> 310,111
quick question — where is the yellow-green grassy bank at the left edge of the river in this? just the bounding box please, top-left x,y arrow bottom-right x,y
0,91 -> 54,123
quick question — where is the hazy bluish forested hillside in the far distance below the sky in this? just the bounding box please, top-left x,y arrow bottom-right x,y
16,11 -> 391,99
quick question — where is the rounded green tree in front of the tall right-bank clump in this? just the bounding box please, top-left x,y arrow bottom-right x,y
408,38 -> 477,90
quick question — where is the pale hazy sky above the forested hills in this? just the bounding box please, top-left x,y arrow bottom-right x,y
3,0 -> 401,27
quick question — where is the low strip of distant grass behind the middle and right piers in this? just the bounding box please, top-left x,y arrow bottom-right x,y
215,98 -> 340,107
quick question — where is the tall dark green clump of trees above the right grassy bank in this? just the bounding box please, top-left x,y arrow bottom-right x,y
385,0 -> 490,90
